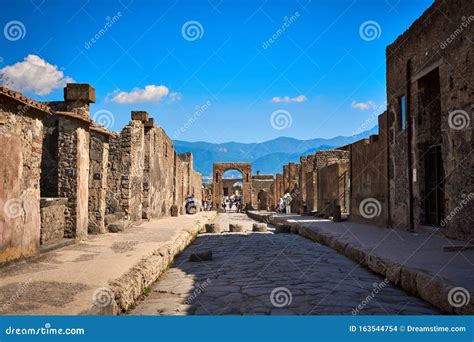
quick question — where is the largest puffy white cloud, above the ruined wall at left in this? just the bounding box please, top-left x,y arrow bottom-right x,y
0,55 -> 74,95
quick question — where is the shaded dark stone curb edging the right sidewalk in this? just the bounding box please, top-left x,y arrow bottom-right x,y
248,213 -> 474,315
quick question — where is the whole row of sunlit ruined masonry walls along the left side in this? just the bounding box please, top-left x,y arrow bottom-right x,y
0,84 -> 202,264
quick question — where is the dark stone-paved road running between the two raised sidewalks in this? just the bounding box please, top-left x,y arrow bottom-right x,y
129,213 -> 440,315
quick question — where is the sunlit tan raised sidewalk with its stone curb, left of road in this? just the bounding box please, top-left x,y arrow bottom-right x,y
0,212 -> 216,315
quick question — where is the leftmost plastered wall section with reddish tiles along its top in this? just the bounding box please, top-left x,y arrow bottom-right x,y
0,87 -> 50,264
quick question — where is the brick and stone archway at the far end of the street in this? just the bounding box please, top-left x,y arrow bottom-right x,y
212,163 -> 252,208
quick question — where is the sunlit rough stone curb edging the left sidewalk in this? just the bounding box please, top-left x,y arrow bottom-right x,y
103,215 -> 215,315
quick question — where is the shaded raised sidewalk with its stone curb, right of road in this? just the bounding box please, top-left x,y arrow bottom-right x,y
249,211 -> 474,314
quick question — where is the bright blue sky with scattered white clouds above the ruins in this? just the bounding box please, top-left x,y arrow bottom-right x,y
0,0 -> 433,142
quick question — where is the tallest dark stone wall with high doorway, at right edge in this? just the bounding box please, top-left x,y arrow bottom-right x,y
387,0 -> 474,240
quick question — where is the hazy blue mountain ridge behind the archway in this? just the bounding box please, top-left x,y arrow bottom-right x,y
174,126 -> 378,176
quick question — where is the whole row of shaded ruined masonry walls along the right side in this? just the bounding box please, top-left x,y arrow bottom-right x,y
274,0 -> 474,241
